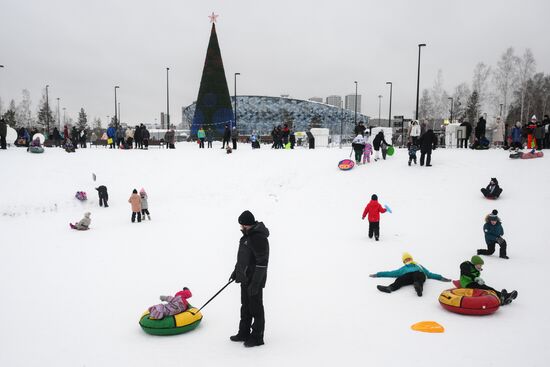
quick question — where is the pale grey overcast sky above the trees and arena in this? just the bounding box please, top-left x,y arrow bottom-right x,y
0,0 -> 550,125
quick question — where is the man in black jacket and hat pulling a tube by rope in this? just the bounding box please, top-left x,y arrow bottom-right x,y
229,210 -> 269,347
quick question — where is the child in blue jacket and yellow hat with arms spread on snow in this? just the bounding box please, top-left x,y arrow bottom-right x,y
370,252 -> 451,297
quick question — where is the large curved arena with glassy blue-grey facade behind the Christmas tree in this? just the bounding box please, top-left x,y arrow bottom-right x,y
183,96 -> 369,136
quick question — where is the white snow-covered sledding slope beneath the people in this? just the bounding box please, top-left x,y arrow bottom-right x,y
0,143 -> 550,367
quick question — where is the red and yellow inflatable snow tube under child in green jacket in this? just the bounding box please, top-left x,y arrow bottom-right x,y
439,288 -> 500,315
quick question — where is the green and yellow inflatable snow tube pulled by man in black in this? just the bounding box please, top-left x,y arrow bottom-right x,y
139,306 -> 202,335
